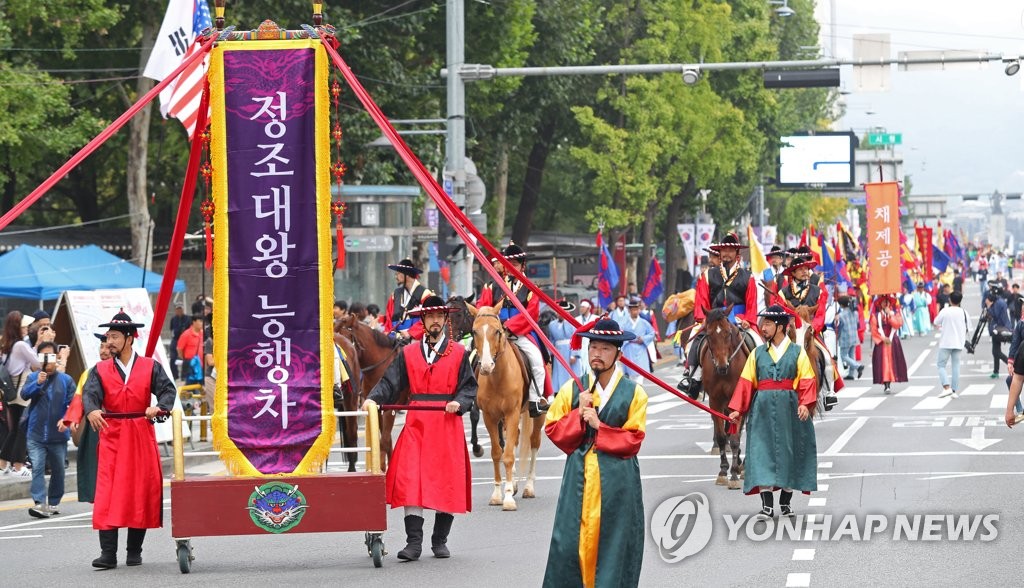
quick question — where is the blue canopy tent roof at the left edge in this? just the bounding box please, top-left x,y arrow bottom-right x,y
0,245 -> 185,300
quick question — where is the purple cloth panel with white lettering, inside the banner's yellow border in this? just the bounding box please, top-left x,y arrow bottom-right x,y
223,48 -> 322,474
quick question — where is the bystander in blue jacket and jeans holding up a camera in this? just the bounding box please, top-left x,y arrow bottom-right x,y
22,341 -> 76,518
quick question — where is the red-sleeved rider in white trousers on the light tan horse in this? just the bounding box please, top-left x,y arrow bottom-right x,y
476,243 -> 548,418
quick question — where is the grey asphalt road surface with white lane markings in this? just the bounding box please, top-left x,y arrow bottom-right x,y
0,285 -> 1024,586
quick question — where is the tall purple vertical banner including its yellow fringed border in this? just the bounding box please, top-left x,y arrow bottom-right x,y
210,40 -> 335,475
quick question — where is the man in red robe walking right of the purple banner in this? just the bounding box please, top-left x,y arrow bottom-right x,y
362,295 -> 476,561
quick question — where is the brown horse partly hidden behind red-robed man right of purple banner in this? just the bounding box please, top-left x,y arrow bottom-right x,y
337,314 -> 409,471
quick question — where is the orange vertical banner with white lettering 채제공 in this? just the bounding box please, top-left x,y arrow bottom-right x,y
864,181 -> 900,296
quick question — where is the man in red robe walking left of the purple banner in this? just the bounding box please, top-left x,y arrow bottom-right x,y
82,310 -> 177,570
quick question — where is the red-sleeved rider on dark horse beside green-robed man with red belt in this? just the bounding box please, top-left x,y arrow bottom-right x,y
676,233 -> 760,400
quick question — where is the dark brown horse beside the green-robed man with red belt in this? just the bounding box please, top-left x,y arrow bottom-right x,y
700,305 -> 748,490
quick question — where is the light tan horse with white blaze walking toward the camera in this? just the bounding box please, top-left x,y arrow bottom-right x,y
470,306 -> 544,510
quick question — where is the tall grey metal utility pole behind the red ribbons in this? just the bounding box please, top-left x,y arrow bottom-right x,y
444,0 -> 473,296
